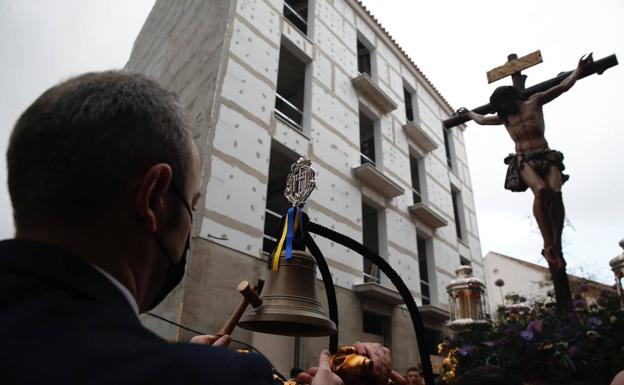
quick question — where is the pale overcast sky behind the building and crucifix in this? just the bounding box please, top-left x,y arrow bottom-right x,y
0,0 -> 624,283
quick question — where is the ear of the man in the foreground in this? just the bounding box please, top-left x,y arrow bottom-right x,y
135,163 -> 173,232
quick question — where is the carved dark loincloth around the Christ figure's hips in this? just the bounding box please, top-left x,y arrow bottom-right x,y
505,148 -> 570,192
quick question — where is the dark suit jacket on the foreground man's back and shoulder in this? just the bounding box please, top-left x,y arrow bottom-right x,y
0,240 -> 272,384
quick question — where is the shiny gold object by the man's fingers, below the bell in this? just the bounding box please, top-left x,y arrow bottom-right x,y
329,346 -> 374,385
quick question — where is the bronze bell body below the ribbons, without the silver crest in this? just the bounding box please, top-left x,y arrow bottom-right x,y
238,250 -> 336,337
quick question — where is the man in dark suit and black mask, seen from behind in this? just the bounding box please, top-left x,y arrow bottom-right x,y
0,72 -> 398,385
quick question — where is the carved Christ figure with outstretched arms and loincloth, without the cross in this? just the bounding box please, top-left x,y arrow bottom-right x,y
457,53 -> 593,269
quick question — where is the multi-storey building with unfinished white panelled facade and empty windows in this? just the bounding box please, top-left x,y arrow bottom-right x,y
126,0 -> 483,372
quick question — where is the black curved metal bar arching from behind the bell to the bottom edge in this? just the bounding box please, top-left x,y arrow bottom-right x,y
303,221 -> 435,385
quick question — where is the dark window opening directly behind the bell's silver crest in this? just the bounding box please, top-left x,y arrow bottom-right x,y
262,142 -> 299,253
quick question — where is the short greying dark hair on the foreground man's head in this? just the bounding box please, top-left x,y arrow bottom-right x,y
7,71 -> 191,231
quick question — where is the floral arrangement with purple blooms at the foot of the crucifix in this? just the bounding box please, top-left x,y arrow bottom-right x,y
442,285 -> 624,384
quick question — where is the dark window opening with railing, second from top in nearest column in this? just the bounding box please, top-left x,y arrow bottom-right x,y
275,46 -> 306,131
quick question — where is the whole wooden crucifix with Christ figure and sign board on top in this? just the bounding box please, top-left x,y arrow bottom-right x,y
443,51 -> 617,309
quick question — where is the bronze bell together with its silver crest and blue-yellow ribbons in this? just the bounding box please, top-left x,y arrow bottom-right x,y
238,158 -> 336,337
